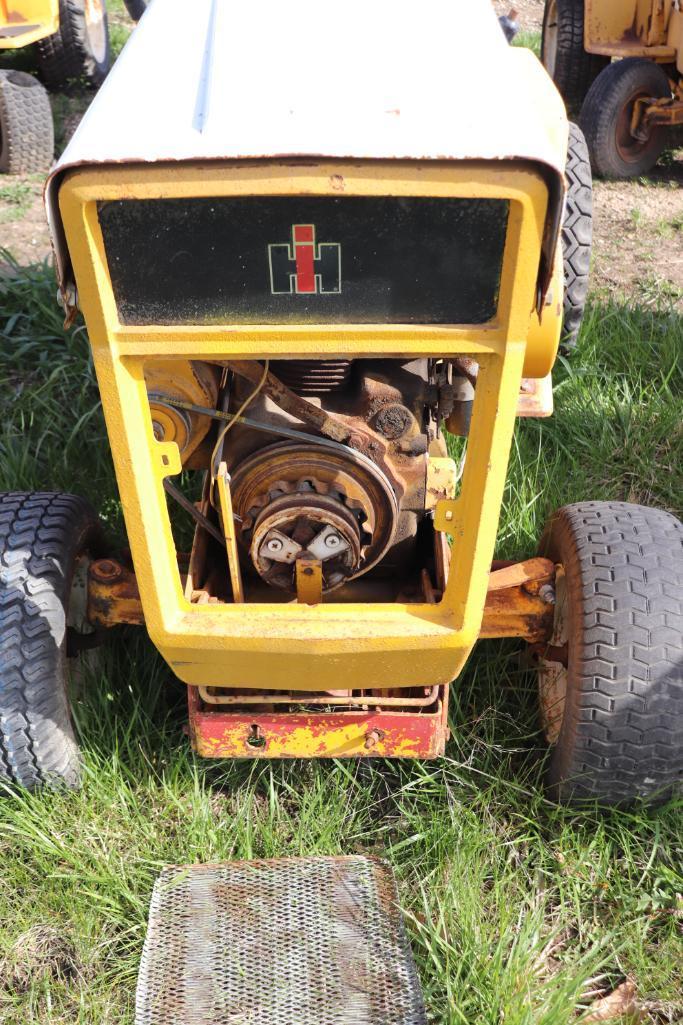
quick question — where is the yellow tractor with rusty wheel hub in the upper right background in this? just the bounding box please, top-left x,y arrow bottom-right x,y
541,0 -> 683,178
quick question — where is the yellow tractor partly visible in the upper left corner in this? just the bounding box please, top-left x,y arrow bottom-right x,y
0,0 -> 111,174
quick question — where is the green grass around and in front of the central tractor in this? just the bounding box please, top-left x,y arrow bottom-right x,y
0,258 -> 683,1025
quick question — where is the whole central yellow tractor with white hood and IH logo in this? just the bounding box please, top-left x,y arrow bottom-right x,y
0,0 -> 683,803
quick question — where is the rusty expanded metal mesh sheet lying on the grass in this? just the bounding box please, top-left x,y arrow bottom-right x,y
135,857 -> 426,1025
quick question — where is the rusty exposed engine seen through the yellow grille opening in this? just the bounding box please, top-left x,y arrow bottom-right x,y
146,359 -> 467,601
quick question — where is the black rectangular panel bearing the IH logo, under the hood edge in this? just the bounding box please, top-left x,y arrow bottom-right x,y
98,196 -> 509,324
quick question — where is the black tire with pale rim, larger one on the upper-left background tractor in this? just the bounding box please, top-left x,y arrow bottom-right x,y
38,0 -> 112,88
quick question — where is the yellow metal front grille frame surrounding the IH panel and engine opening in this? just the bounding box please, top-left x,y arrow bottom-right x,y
59,161 -> 562,713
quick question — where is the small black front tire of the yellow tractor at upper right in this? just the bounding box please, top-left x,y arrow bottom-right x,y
579,57 -> 671,178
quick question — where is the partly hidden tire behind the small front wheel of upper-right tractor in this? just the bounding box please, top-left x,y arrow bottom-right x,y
540,0 -> 609,114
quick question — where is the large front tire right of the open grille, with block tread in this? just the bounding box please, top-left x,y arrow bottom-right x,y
539,502 -> 683,805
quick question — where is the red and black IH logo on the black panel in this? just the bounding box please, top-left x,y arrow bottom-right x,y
268,224 -> 342,295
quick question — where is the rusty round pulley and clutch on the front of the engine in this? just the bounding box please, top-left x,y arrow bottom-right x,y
232,442 -> 398,592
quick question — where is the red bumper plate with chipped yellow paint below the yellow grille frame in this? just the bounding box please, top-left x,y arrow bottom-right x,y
188,687 -> 448,759
